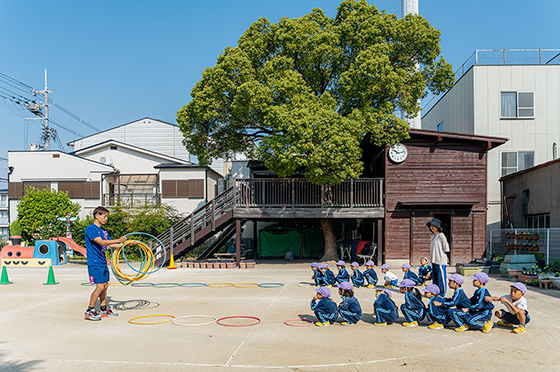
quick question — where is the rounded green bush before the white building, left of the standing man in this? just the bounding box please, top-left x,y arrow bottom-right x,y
17,188 -> 80,244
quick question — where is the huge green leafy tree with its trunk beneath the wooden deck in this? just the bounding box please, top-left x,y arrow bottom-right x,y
177,0 -> 454,259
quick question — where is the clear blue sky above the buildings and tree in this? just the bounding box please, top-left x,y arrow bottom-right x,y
0,0 -> 560,178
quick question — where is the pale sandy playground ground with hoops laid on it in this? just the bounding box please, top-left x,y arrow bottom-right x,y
0,261 -> 560,371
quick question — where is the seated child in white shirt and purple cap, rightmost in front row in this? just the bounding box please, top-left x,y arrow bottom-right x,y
485,282 -> 531,334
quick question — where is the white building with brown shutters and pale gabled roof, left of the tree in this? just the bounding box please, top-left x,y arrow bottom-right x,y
8,118 -> 223,221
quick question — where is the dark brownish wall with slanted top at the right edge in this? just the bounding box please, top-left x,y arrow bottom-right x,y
503,161 -> 560,228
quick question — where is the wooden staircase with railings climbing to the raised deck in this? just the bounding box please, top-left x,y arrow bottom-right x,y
149,187 -> 235,266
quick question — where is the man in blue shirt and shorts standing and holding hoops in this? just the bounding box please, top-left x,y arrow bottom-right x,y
84,207 -> 126,320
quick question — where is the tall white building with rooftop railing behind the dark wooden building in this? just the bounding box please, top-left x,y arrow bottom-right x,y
422,50 -> 560,229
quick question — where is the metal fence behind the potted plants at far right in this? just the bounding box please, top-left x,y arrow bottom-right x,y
488,228 -> 560,264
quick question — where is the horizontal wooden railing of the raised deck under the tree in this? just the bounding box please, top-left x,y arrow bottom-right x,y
234,178 -> 384,208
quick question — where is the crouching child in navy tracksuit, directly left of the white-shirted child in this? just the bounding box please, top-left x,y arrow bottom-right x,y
453,272 -> 494,333
